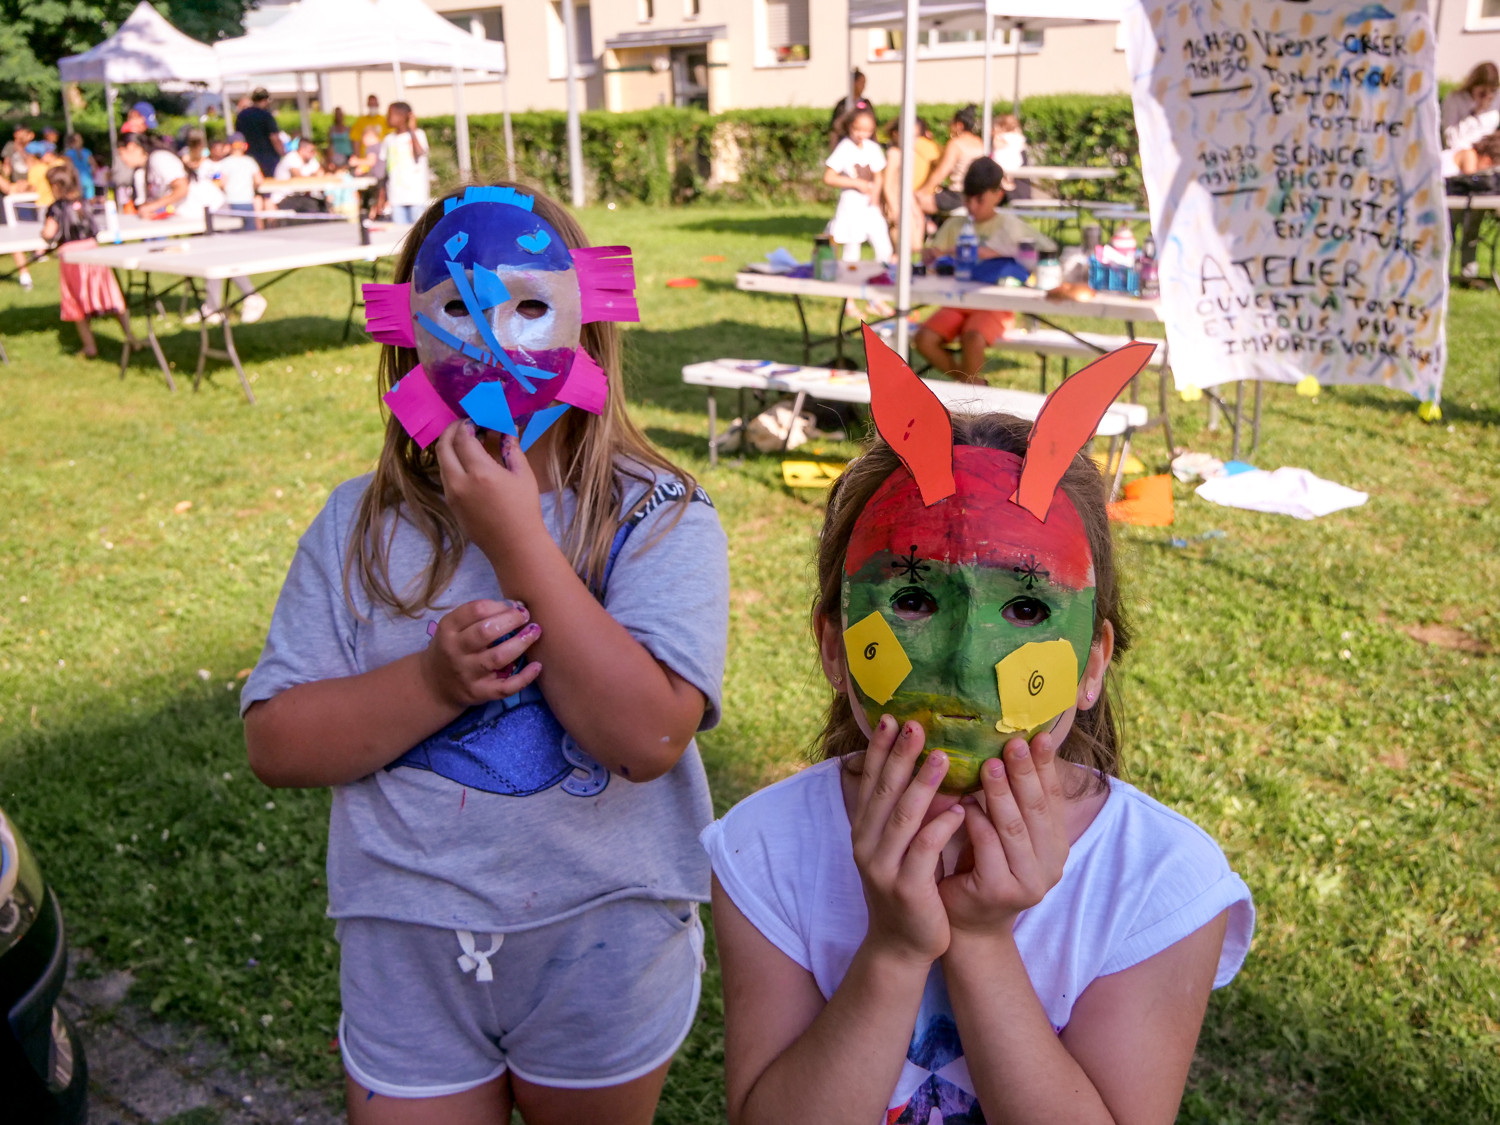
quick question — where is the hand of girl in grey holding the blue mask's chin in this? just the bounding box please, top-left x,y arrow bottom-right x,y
438,420 -> 548,563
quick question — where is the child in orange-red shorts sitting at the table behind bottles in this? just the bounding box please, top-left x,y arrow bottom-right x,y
917,156 -> 1058,383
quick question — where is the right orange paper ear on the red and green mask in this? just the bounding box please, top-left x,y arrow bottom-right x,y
1014,342 -> 1157,521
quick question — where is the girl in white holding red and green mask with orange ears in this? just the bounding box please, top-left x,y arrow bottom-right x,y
704,335 -> 1254,1125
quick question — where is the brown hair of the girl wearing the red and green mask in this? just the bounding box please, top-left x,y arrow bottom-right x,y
812,414 -> 1131,777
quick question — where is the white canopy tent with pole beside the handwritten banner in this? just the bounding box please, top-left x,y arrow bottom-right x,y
849,0 -> 1127,359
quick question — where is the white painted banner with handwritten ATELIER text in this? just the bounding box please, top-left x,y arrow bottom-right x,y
1125,0 -> 1449,402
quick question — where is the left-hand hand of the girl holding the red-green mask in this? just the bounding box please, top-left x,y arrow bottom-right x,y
851,716 -> 963,963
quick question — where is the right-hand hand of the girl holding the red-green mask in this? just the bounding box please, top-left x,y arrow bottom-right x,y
938,734 -> 1068,935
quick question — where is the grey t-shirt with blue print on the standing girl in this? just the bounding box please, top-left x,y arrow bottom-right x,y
240,476 -> 729,933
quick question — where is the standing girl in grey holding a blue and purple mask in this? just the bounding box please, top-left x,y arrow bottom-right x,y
243,186 -> 728,1125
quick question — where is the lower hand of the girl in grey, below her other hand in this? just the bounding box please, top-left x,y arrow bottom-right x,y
422,600 -> 542,708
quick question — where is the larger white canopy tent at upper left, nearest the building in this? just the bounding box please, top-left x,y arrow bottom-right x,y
213,0 -> 515,176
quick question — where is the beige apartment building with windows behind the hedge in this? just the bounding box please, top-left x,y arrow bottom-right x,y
320,0 -> 1130,123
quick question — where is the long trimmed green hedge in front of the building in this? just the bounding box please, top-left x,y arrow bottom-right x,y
11,95 -> 1142,206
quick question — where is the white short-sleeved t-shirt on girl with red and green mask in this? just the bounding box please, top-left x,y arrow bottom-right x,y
702,761 -> 1256,1125
